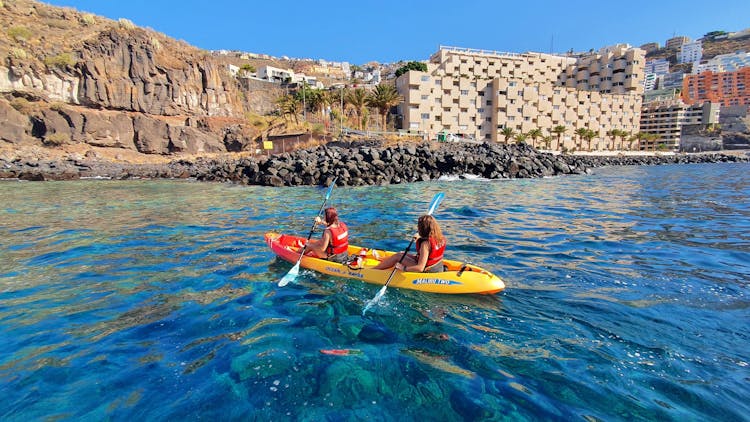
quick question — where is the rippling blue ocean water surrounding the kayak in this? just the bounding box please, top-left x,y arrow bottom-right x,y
0,164 -> 750,421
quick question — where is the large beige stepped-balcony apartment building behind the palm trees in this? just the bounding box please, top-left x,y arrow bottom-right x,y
396,45 -> 645,148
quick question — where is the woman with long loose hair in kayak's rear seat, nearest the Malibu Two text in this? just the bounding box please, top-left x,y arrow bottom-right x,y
374,214 -> 447,273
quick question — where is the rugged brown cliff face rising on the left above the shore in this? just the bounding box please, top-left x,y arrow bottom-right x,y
0,0 -> 270,154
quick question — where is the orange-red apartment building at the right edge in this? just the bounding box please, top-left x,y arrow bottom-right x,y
682,67 -> 750,106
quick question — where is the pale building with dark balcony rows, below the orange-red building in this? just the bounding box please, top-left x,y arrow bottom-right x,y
640,98 -> 720,151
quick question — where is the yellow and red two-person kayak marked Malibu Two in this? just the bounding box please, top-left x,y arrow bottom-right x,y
265,232 -> 505,294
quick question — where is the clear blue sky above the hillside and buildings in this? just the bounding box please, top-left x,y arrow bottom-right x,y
39,0 -> 750,64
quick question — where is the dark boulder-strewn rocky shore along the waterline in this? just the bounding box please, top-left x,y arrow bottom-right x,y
0,141 -> 750,186
